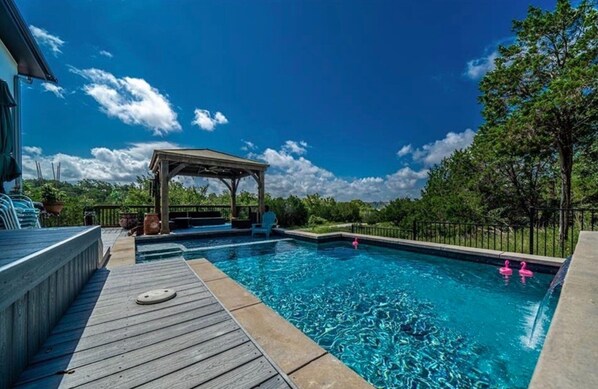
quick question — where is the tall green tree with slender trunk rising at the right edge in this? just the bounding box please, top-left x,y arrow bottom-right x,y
480,0 -> 598,239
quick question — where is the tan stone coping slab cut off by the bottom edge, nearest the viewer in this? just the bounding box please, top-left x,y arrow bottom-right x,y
290,354 -> 372,389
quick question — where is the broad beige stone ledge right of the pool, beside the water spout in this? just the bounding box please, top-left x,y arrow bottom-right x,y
529,232 -> 598,389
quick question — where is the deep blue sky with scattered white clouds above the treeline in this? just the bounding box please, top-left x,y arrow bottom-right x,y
17,0 -> 554,201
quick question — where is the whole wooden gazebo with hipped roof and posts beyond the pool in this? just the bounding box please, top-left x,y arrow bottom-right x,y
149,149 -> 269,234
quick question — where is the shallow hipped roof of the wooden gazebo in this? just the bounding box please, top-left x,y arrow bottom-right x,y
149,149 -> 269,178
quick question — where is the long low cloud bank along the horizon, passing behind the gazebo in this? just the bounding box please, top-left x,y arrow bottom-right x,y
23,142 -> 428,201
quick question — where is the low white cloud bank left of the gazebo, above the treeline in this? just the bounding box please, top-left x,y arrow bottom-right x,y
23,142 -> 178,183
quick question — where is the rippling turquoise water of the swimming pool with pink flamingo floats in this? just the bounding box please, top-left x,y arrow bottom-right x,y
139,236 -> 556,388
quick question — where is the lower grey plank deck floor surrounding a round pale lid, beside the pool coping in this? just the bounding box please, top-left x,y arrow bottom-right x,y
16,260 -> 294,388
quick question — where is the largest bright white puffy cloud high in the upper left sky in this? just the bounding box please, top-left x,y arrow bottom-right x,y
70,67 -> 181,135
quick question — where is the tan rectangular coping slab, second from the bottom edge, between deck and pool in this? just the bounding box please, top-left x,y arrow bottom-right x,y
233,304 -> 326,374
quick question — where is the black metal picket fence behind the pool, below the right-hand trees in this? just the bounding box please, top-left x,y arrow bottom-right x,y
351,208 -> 598,258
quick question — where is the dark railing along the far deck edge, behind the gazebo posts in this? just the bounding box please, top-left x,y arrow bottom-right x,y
93,204 -> 257,227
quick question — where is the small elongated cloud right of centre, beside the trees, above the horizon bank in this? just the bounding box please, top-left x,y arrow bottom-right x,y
397,128 -> 475,166
